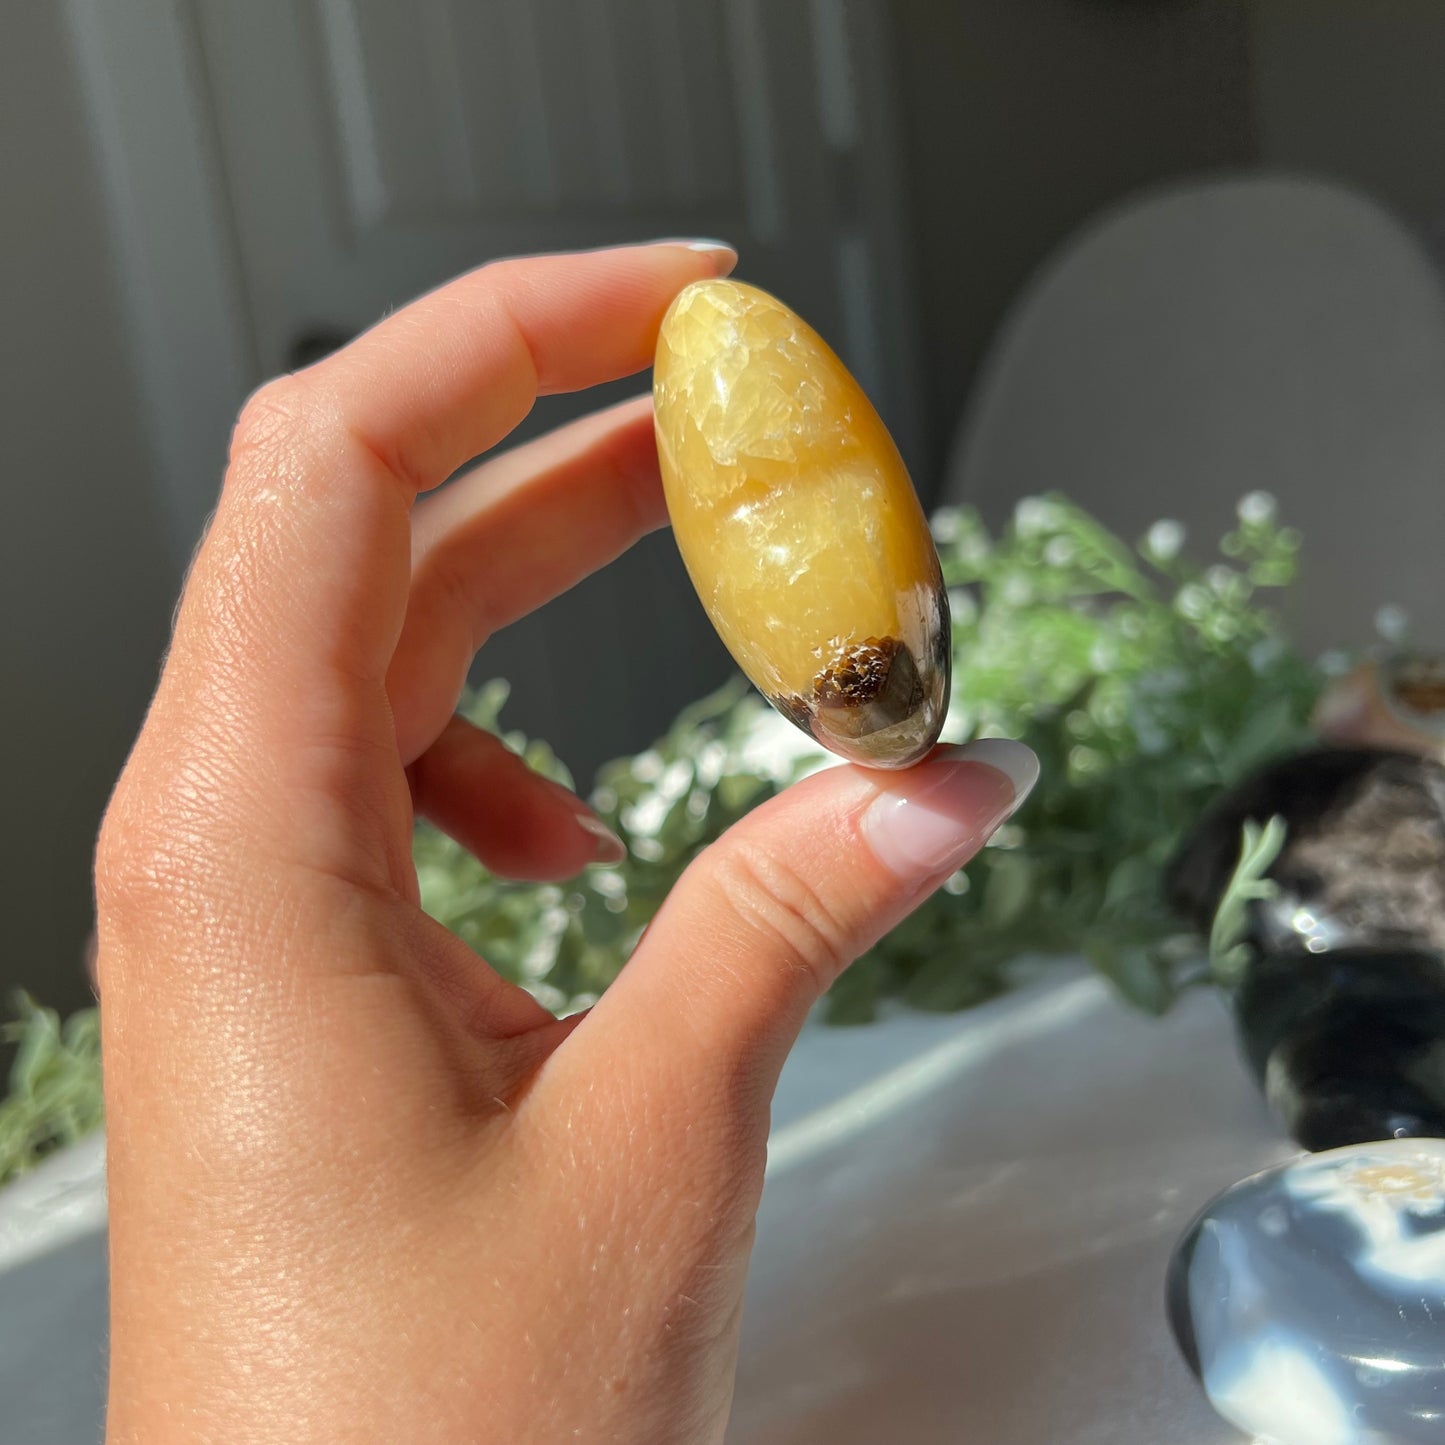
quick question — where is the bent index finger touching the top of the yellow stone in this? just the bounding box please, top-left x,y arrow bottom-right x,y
173,241 -> 736,716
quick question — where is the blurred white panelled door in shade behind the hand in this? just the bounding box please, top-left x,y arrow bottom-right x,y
72,0 -> 919,773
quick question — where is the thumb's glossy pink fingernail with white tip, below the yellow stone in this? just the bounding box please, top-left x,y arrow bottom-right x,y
863,737 -> 1039,879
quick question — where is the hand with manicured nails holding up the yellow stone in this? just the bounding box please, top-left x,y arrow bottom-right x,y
97,244 -> 1032,1445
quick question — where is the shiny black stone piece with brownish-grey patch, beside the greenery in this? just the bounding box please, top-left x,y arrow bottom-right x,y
1168,747 -> 1445,1150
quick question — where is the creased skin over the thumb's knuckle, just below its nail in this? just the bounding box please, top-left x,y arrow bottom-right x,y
718,840 -> 854,993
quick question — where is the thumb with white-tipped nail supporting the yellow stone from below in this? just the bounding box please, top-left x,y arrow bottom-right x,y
572,738 -> 1039,1108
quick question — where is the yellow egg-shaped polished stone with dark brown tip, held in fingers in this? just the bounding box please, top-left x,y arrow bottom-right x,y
653,280 -> 949,767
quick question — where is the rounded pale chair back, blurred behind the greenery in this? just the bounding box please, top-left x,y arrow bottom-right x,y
942,176 -> 1445,649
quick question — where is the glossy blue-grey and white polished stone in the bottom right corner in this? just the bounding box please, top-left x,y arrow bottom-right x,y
1169,1139 -> 1445,1445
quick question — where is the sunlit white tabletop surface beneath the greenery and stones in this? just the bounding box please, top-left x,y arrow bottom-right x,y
0,965 -> 1296,1445
